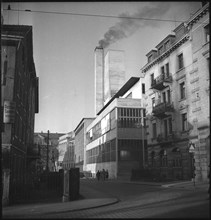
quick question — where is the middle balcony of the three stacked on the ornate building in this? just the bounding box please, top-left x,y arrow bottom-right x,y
152,102 -> 174,118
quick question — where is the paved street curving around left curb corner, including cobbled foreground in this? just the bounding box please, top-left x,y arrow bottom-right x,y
8,180 -> 206,219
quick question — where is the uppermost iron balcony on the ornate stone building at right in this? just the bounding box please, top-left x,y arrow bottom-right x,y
151,73 -> 172,90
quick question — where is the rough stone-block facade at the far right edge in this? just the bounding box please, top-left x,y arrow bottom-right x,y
186,2 -> 210,180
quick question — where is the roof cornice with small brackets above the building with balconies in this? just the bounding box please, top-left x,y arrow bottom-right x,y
141,34 -> 190,73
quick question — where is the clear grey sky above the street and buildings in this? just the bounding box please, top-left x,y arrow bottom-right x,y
1,1 -> 201,133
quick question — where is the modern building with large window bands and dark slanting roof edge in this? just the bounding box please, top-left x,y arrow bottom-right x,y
85,77 -> 147,179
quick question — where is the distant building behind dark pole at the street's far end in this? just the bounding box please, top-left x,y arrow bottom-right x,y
34,132 -> 64,173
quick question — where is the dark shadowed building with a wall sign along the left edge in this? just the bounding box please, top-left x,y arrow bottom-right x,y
1,25 -> 38,205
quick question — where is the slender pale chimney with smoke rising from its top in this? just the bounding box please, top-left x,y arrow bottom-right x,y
94,47 -> 104,115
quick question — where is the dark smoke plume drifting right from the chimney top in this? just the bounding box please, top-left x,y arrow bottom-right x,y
99,2 -> 170,48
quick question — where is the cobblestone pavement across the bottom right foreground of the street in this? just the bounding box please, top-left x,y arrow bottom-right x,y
42,189 -> 210,219
